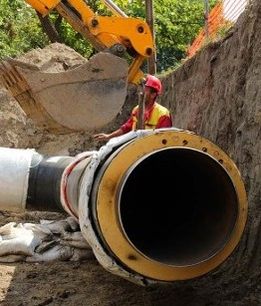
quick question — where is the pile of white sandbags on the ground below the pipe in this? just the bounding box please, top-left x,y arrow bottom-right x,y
0,218 -> 92,262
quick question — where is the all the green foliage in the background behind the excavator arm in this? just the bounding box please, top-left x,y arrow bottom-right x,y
0,0 -> 216,71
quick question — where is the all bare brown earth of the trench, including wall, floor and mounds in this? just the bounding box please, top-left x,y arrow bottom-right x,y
0,0 -> 261,306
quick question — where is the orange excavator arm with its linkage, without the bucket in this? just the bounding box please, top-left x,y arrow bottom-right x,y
26,0 -> 154,84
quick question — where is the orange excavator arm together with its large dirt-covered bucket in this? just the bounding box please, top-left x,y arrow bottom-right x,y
0,0 -> 154,133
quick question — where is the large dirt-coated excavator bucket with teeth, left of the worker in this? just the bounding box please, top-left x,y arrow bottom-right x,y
0,52 -> 128,133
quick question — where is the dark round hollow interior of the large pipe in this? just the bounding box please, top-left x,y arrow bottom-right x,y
119,148 -> 237,266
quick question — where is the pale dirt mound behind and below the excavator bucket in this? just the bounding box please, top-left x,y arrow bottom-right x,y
0,43 -> 96,155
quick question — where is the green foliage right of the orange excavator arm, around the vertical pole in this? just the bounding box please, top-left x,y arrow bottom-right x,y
115,0 -> 216,71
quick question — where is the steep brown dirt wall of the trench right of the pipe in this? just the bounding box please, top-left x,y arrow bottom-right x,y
159,1 -> 261,284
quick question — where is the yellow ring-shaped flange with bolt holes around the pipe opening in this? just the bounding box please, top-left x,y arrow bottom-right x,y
96,129 -> 247,281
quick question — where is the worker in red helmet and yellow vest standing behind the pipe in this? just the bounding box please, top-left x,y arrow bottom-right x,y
94,75 -> 172,140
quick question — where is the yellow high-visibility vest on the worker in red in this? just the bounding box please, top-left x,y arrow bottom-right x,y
132,102 -> 170,131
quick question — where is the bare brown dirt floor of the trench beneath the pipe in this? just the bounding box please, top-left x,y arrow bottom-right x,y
0,212 -> 261,306
